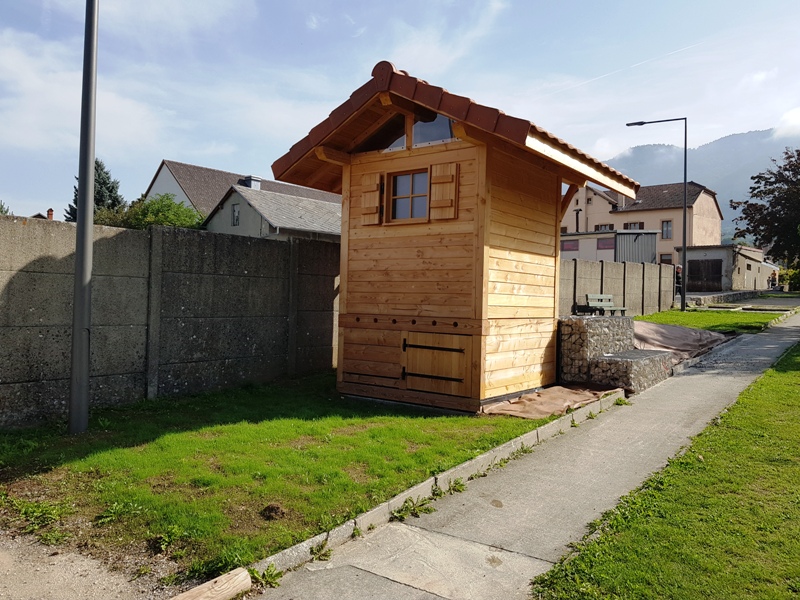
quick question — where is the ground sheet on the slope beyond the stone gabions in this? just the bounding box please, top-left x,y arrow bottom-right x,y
633,321 -> 735,364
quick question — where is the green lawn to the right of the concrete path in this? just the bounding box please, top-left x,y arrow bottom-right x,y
532,346 -> 800,600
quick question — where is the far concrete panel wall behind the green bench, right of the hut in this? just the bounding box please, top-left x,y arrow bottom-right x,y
558,259 -> 675,317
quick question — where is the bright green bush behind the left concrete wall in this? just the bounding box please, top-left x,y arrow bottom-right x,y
94,194 -> 203,229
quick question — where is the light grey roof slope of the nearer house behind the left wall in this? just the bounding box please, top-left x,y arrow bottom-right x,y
233,185 -> 342,235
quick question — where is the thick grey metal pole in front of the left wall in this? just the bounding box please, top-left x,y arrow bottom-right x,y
69,0 -> 99,433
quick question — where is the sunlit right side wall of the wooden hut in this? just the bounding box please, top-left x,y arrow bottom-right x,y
481,149 -> 561,398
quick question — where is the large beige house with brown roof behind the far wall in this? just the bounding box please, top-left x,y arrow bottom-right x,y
561,181 -> 723,264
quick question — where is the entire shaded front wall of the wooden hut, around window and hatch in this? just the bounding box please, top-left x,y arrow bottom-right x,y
339,142 -> 485,410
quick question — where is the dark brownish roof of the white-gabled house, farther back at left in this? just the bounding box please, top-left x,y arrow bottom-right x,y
145,160 -> 342,216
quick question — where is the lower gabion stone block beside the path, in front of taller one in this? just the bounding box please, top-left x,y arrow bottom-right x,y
589,350 -> 672,394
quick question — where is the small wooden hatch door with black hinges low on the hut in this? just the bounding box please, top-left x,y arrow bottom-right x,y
403,331 -> 472,396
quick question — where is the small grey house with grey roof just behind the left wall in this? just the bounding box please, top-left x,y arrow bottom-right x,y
203,182 -> 342,243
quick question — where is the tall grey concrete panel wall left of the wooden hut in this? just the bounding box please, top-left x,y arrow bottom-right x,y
0,217 -> 339,427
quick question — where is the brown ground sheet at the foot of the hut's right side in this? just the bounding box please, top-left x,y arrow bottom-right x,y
481,385 -> 624,419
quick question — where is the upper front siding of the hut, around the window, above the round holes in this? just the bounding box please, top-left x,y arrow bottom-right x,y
343,143 -> 478,319
